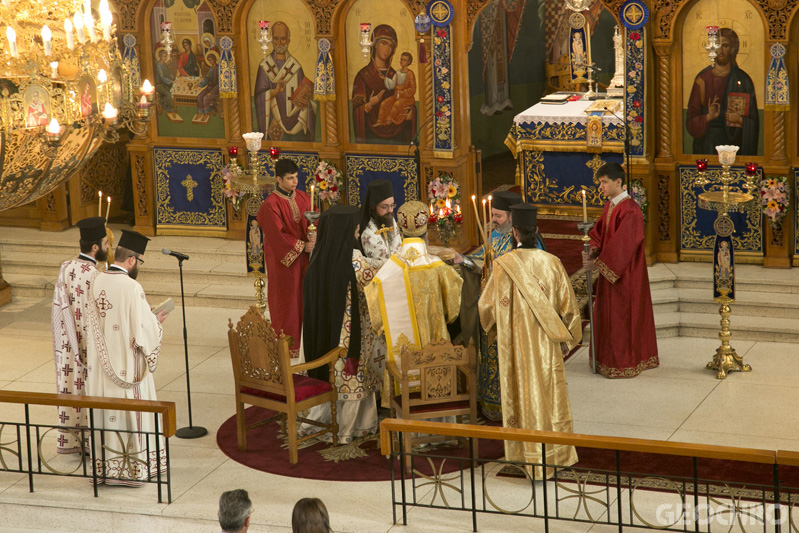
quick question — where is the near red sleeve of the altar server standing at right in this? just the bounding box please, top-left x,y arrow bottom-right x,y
596,198 -> 644,283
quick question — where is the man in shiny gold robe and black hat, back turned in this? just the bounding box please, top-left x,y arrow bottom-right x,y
479,206 -> 582,479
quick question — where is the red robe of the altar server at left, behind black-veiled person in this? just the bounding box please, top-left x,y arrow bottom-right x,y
258,189 -> 311,358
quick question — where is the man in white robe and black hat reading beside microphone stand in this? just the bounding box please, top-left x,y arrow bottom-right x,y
86,230 -> 166,486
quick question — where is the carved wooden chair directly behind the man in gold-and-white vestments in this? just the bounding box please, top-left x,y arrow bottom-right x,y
386,340 -> 477,468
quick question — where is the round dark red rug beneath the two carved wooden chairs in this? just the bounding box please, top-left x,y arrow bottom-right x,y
216,407 -> 505,481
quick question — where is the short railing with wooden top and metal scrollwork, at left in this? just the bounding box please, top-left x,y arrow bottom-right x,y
0,391 -> 177,503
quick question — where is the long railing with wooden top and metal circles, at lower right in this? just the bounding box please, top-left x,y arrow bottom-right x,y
380,419 -> 799,532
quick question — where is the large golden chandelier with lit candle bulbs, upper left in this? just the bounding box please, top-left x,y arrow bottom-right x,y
0,0 -> 155,211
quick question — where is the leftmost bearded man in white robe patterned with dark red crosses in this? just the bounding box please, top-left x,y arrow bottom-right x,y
50,217 -> 108,454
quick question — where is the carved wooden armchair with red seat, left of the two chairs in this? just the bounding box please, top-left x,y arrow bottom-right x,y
228,306 -> 343,464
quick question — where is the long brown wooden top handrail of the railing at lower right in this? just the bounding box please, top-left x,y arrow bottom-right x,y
380,418 -> 776,464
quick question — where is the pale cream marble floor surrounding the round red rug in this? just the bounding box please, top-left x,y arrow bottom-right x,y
0,294 -> 799,533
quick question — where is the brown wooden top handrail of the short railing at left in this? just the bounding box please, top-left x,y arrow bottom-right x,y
0,391 -> 177,437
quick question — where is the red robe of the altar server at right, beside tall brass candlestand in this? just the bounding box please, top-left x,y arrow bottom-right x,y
589,193 -> 660,378
